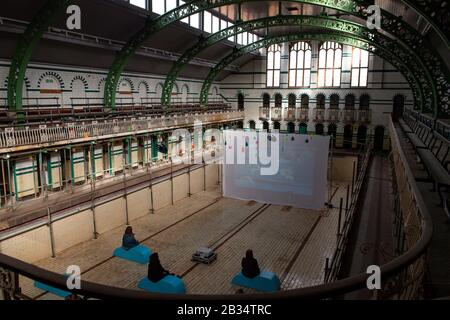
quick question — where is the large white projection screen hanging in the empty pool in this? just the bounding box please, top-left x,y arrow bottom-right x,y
223,131 -> 330,210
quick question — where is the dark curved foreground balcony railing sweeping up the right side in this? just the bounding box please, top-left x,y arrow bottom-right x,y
0,118 -> 432,301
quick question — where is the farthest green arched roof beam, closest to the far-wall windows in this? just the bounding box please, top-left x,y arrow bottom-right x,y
200,32 -> 420,109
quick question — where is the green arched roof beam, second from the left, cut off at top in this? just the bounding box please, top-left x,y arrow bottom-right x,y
103,0 -> 366,110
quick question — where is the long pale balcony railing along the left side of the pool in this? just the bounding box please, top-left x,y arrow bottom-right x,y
0,110 -> 244,148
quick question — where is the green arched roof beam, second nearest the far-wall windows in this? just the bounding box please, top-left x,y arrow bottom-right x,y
161,13 -> 449,116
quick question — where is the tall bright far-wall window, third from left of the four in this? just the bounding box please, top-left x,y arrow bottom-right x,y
318,41 -> 342,87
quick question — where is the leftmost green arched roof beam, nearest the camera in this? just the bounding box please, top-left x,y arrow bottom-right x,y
8,0 -> 72,121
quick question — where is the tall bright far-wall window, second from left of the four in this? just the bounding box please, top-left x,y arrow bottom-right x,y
289,42 -> 311,87
